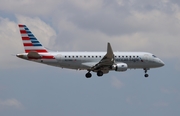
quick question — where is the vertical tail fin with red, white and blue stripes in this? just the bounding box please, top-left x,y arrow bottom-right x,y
19,24 -> 48,53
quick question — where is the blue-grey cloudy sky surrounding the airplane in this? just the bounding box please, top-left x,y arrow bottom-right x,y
0,0 -> 180,116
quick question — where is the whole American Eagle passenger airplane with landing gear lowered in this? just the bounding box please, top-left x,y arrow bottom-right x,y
16,24 -> 165,78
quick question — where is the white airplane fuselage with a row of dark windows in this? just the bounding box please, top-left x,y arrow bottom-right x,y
17,52 -> 164,70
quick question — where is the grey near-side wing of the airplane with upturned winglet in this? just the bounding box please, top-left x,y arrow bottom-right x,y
90,43 -> 114,71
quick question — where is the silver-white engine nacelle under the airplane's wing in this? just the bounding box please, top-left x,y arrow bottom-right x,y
113,63 -> 128,72
